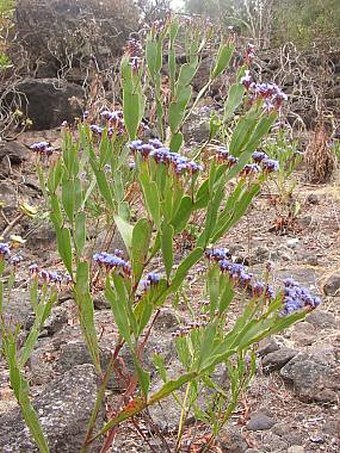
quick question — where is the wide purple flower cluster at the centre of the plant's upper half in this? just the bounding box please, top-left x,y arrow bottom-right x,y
129,139 -> 203,174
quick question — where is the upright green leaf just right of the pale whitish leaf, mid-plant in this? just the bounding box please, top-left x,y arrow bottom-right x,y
131,219 -> 152,285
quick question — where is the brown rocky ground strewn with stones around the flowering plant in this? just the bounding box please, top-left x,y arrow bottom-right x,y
0,132 -> 340,453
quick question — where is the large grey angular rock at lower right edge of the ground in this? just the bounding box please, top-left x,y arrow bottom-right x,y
280,349 -> 340,403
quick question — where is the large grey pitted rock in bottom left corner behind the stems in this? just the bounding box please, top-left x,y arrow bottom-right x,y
0,365 -> 104,453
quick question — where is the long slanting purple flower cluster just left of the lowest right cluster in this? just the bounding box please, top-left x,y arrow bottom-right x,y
205,248 -> 274,299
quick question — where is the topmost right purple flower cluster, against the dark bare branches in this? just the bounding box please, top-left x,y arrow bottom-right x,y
241,71 -> 288,112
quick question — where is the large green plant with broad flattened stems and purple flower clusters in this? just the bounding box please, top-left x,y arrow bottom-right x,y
0,15 -> 319,451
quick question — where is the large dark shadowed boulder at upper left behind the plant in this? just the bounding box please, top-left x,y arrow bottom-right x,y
7,79 -> 84,131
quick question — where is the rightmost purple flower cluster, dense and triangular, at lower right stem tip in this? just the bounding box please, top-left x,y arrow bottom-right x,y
281,278 -> 321,316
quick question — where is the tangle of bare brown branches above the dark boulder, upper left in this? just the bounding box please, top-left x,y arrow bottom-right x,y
11,0 -> 139,78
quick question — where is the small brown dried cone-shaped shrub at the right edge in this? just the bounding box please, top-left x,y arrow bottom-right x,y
305,122 -> 336,183
